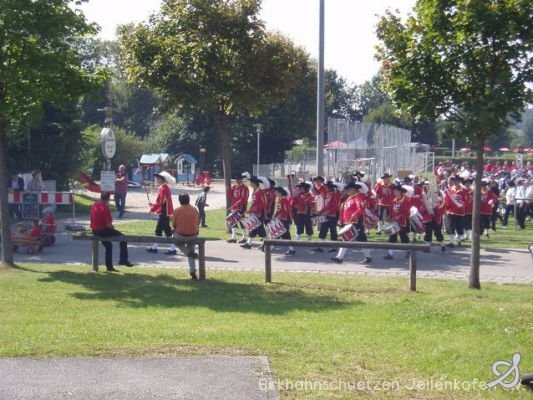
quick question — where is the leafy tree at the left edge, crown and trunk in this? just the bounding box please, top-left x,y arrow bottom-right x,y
0,0 -> 105,266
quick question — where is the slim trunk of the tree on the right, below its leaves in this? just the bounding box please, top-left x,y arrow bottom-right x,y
468,136 -> 485,289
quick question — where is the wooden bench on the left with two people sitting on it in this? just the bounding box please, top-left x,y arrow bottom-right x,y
72,234 -> 205,281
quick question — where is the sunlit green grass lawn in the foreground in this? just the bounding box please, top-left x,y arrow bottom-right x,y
0,264 -> 533,400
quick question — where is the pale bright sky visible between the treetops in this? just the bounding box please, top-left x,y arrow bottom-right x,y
82,0 -> 415,84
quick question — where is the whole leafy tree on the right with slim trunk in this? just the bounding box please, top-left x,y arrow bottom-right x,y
377,0 -> 533,288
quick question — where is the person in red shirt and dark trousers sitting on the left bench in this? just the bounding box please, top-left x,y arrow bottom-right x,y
91,192 -> 133,272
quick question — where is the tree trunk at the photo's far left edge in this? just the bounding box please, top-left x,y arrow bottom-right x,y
0,117 -> 15,269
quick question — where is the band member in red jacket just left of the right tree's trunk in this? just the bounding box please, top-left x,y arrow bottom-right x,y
444,176 -> 466,247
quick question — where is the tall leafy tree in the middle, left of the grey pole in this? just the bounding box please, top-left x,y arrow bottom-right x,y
119,0 -> 303,211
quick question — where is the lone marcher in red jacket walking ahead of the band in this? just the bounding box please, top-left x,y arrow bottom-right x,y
146,171 -> 177,255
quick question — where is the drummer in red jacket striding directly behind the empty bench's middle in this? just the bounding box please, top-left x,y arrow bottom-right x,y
331,182 -> 372,264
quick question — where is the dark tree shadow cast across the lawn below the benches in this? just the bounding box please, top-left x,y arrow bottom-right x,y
40,271 -> 361,315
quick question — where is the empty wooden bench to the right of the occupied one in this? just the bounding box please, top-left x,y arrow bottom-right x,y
263,239 -> 431,291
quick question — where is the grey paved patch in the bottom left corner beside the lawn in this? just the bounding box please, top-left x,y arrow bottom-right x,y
0,357 -> 277,400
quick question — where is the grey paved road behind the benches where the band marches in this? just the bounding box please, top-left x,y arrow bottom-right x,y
15,216 -> 533,284
